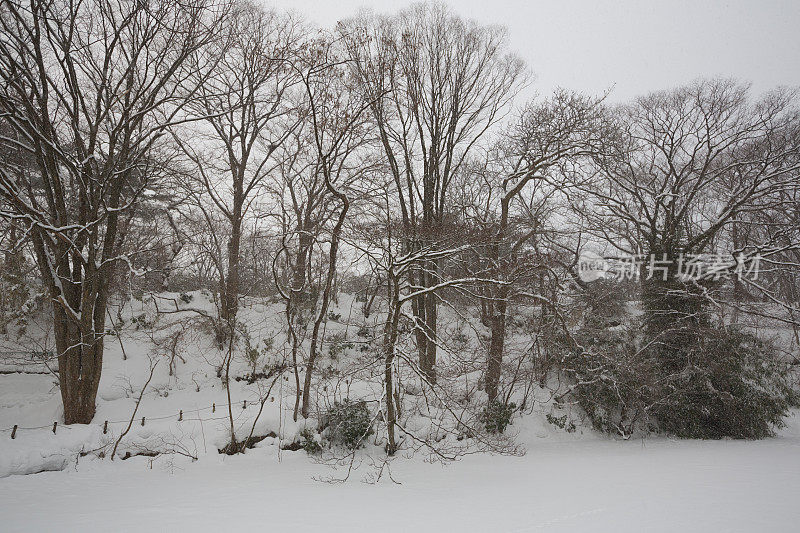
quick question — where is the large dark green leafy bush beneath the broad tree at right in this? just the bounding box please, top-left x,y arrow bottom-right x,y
558,314 -> 797,439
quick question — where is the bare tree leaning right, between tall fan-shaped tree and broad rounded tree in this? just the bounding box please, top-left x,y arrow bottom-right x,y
468,91 -> 603,401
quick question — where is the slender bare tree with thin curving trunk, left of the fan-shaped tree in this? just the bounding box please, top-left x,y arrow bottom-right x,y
274,36 -> 370,419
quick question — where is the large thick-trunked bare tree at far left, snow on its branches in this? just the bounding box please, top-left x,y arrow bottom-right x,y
0,0 -> 225,424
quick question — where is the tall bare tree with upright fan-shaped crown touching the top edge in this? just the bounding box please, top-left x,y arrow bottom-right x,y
339,4 -> 524,381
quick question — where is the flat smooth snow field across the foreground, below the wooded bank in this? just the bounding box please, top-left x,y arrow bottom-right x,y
0,424 -> 800,532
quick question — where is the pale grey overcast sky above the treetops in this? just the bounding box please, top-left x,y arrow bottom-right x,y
265,0 -> 800,101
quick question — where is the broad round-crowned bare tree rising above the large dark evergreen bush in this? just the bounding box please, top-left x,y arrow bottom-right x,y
589,80 -> 800,364
